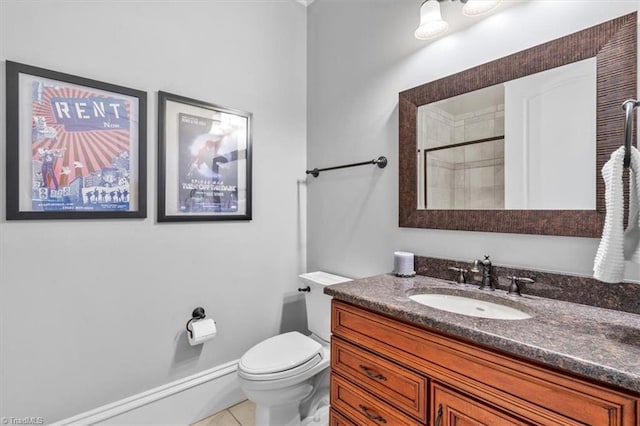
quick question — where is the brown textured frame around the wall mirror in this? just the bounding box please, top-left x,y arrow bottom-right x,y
399,13 -> 637,237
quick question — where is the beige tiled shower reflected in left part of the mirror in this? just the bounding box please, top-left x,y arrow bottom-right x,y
418,105 -> 504,210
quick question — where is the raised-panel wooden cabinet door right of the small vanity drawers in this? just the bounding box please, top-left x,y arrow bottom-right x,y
431,383 -> 534,426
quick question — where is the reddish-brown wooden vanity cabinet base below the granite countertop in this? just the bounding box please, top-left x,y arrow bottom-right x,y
330,299 -> 640,426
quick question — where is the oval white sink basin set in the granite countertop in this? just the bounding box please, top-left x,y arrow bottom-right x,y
409,293 -> 531,320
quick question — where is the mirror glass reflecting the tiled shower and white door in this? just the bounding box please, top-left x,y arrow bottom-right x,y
417,58 -> 596,210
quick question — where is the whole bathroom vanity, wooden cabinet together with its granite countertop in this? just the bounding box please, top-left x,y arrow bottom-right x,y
325,275 -> 640,426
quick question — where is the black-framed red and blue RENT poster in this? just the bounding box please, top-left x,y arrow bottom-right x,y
6,61 -> 147,220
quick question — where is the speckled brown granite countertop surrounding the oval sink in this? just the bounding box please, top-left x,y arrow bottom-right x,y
325,274 -> 640,392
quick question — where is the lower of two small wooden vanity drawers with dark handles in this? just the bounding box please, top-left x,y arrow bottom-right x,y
330,374 -> 421,426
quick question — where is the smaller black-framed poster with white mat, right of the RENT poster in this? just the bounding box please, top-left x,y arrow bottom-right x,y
158,92 -> 251,222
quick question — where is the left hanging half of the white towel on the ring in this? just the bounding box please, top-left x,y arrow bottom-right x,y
593,147 -> 624,283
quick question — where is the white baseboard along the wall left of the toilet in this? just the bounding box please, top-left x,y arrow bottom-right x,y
53,360 -> 246,426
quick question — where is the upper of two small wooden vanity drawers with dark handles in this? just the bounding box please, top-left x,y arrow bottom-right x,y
331,337 -> 428,422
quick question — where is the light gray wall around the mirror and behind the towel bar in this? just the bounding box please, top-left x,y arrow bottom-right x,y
307,0 -> 640,279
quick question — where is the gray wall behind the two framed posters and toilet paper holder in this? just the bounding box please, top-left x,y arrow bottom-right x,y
0,0 -> 306,423
